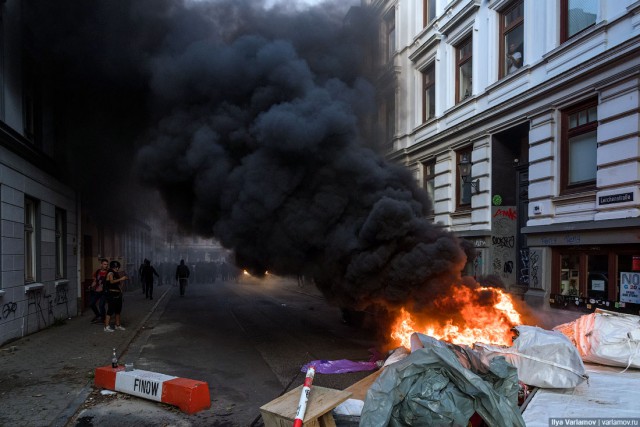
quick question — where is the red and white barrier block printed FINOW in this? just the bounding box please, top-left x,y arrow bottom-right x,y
94,366 -> 211,414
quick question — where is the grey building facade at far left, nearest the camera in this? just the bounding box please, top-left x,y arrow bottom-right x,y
0,1 -> 79,344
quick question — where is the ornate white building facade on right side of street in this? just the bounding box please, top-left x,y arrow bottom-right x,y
363,0 -> 640,314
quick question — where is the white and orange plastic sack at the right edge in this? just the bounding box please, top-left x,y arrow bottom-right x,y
554,310 -> 640,368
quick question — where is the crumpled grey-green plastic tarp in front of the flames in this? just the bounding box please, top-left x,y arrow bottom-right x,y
360,334 -> 525,427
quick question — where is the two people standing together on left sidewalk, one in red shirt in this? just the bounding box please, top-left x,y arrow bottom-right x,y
89,258 -> 128,332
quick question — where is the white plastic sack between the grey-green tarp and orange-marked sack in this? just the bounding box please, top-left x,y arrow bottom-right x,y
474,326 -> 589,388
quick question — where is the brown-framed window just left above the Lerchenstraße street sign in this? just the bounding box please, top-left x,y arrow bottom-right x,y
561,100 -> 598,192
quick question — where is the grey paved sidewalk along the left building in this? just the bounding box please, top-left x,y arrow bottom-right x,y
0,285 -> 172,427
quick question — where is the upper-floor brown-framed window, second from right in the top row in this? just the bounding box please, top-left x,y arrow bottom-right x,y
500,1 -> 524,77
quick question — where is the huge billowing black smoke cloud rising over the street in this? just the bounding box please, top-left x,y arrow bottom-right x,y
27,0 -> 465,314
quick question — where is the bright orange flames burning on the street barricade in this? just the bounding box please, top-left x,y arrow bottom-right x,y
391,286 -> 522,348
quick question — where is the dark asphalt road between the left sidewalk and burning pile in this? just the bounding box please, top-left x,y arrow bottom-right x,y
68,276 -> 377,426
